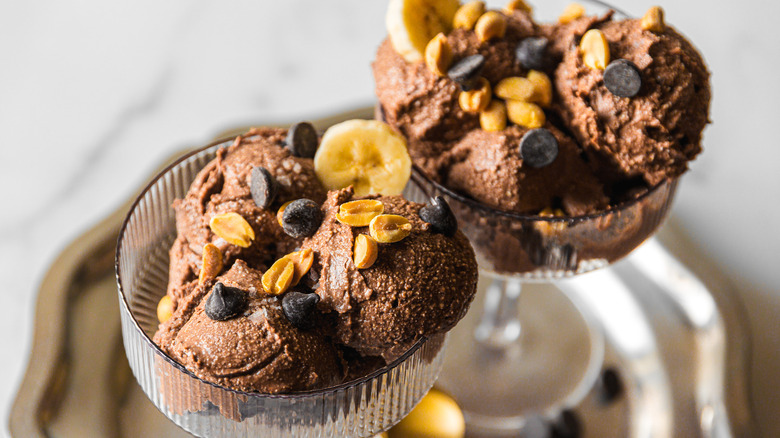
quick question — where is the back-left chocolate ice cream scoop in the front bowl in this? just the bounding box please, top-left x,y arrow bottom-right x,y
168,128 -> 325,302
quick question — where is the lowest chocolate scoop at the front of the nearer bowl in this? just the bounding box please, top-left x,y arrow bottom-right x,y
155,260 -> 346,394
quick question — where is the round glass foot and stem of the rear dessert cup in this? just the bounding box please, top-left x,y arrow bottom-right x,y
437,272 -> 604,435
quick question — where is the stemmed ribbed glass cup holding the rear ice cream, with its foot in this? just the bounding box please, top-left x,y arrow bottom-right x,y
405,168 -> 677,433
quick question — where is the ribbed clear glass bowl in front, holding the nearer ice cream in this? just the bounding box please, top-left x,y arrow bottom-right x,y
116,138 -> 446,437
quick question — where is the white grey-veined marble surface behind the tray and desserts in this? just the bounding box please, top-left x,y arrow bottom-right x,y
0,0 -> 780,436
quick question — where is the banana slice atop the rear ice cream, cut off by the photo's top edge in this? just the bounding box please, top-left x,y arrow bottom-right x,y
385,0 -> 460,62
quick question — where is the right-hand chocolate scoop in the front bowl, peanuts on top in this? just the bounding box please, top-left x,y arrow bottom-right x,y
303,188 -> 477,359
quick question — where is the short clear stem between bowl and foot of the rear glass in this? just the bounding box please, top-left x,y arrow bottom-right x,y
474,278 -> 523,349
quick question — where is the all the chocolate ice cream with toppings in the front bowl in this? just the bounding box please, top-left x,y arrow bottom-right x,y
154,122 -> 477,393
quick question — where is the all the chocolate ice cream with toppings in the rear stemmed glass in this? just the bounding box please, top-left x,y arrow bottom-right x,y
373,4 -> 710,216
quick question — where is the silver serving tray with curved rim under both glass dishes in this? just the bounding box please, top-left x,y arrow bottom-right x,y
10,108 -> 754,438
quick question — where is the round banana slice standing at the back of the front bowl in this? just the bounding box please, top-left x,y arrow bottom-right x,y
314,120 -> 412,196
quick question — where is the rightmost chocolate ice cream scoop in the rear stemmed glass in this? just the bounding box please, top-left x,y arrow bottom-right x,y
555,17 -> 710,186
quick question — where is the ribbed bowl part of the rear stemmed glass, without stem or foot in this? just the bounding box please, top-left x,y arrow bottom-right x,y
405,166 -> 678,280
